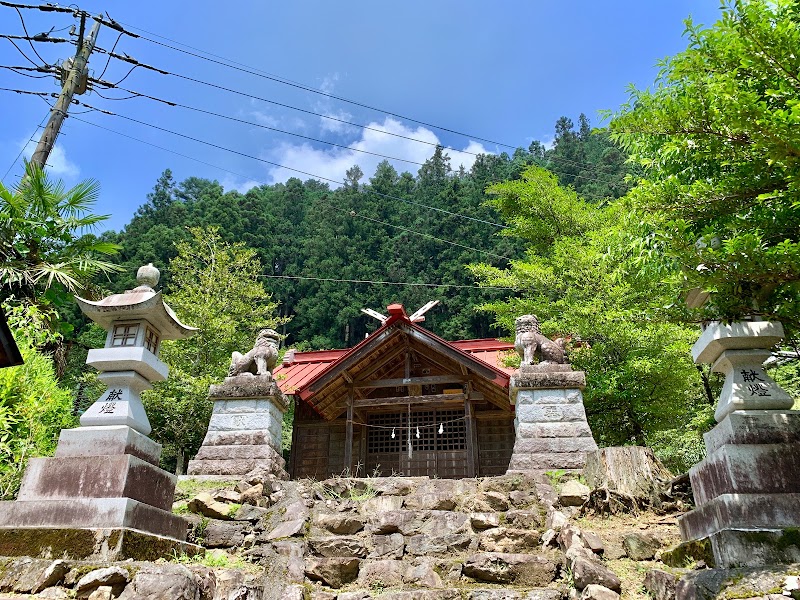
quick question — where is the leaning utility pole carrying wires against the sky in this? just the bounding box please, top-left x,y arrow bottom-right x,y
31,12 -> 100,169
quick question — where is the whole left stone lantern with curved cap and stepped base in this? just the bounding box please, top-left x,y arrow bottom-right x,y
0,265 -> 201,560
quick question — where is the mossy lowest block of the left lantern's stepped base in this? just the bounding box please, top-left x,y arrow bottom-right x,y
0,527 -> 205,562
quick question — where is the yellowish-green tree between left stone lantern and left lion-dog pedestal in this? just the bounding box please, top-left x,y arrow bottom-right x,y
143,227 -> 284,473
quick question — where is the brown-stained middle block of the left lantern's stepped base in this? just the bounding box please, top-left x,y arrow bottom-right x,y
17,454 -> 178,508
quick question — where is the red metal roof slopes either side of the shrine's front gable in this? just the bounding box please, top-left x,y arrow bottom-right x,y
273,326 -> 516,394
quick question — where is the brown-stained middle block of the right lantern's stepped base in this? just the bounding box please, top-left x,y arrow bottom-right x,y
689,443 -> 800,506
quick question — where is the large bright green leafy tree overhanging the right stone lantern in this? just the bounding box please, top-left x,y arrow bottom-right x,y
610,0 -> 800,334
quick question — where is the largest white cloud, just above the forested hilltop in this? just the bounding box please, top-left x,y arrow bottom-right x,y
262,117 -> 490,187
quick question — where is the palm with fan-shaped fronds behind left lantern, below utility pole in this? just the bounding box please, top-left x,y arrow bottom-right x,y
0,163 -> 120,299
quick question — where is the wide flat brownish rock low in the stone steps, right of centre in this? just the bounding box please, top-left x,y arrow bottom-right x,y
462,552 -> 558,587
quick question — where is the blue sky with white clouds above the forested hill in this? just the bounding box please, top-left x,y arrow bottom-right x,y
0,0 -> 719,229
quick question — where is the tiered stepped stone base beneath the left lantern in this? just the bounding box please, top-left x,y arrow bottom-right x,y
0,425 -> 201,559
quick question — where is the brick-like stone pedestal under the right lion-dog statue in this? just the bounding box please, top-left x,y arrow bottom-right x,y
508,365 -> 597,472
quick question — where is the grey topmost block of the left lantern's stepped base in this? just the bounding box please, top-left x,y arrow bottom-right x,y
55,425 -> 161,466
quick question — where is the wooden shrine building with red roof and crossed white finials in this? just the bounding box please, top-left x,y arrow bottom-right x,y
274,303 -> 515,479
